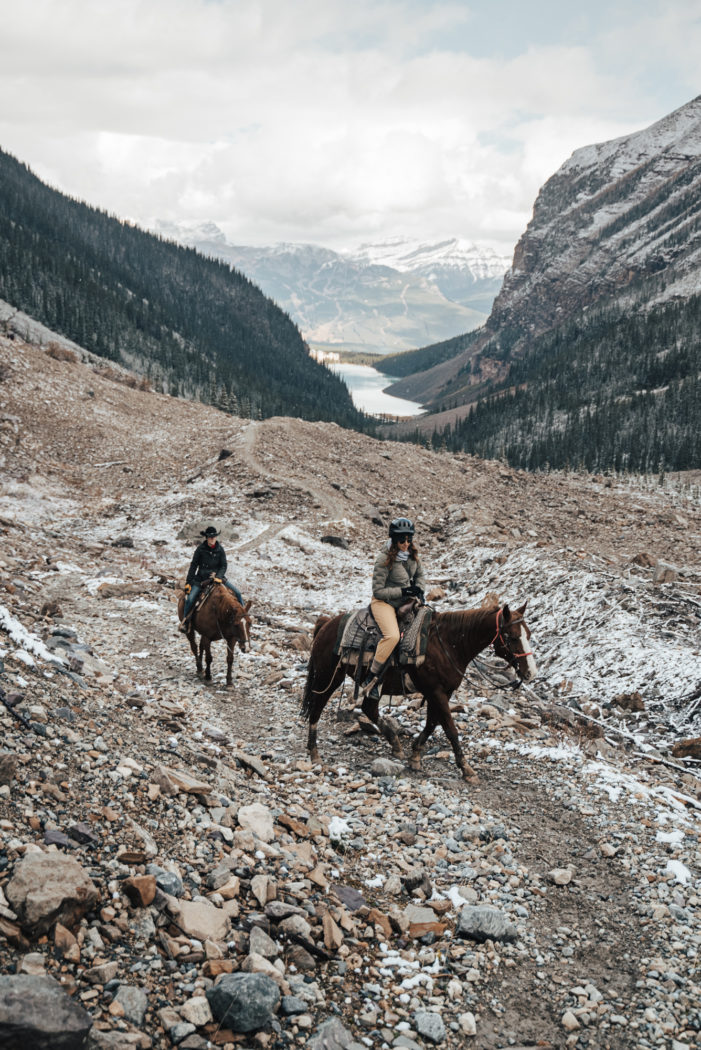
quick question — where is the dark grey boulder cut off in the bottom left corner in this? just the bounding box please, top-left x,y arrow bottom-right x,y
0,973 -> 92,1050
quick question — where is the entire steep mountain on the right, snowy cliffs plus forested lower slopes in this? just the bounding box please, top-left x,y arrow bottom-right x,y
390,96 -> 701,470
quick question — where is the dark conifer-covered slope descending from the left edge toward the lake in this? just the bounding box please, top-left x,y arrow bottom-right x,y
0,150 -> 373,431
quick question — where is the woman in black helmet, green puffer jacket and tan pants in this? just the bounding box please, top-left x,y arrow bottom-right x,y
362,518 -> 424,700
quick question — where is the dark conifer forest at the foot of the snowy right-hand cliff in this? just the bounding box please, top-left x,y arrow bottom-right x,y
413,287 -> 701,473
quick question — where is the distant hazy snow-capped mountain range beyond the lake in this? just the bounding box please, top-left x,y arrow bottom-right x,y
155,223 -> 508,354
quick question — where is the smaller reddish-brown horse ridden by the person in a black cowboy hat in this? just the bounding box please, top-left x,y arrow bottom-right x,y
177,583 -> 251,686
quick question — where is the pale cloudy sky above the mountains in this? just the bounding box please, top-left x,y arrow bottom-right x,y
0,0 -> 701,254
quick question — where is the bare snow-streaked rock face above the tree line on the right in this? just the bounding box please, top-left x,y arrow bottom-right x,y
488,96 -> 701,335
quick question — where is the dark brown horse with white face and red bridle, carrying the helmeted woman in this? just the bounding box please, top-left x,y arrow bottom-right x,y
301,604 -> 535,781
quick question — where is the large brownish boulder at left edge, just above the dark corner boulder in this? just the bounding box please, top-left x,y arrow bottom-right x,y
5,853 -> 99,935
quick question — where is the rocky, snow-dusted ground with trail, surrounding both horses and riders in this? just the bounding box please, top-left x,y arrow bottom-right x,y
0,336 -> 701,1050
